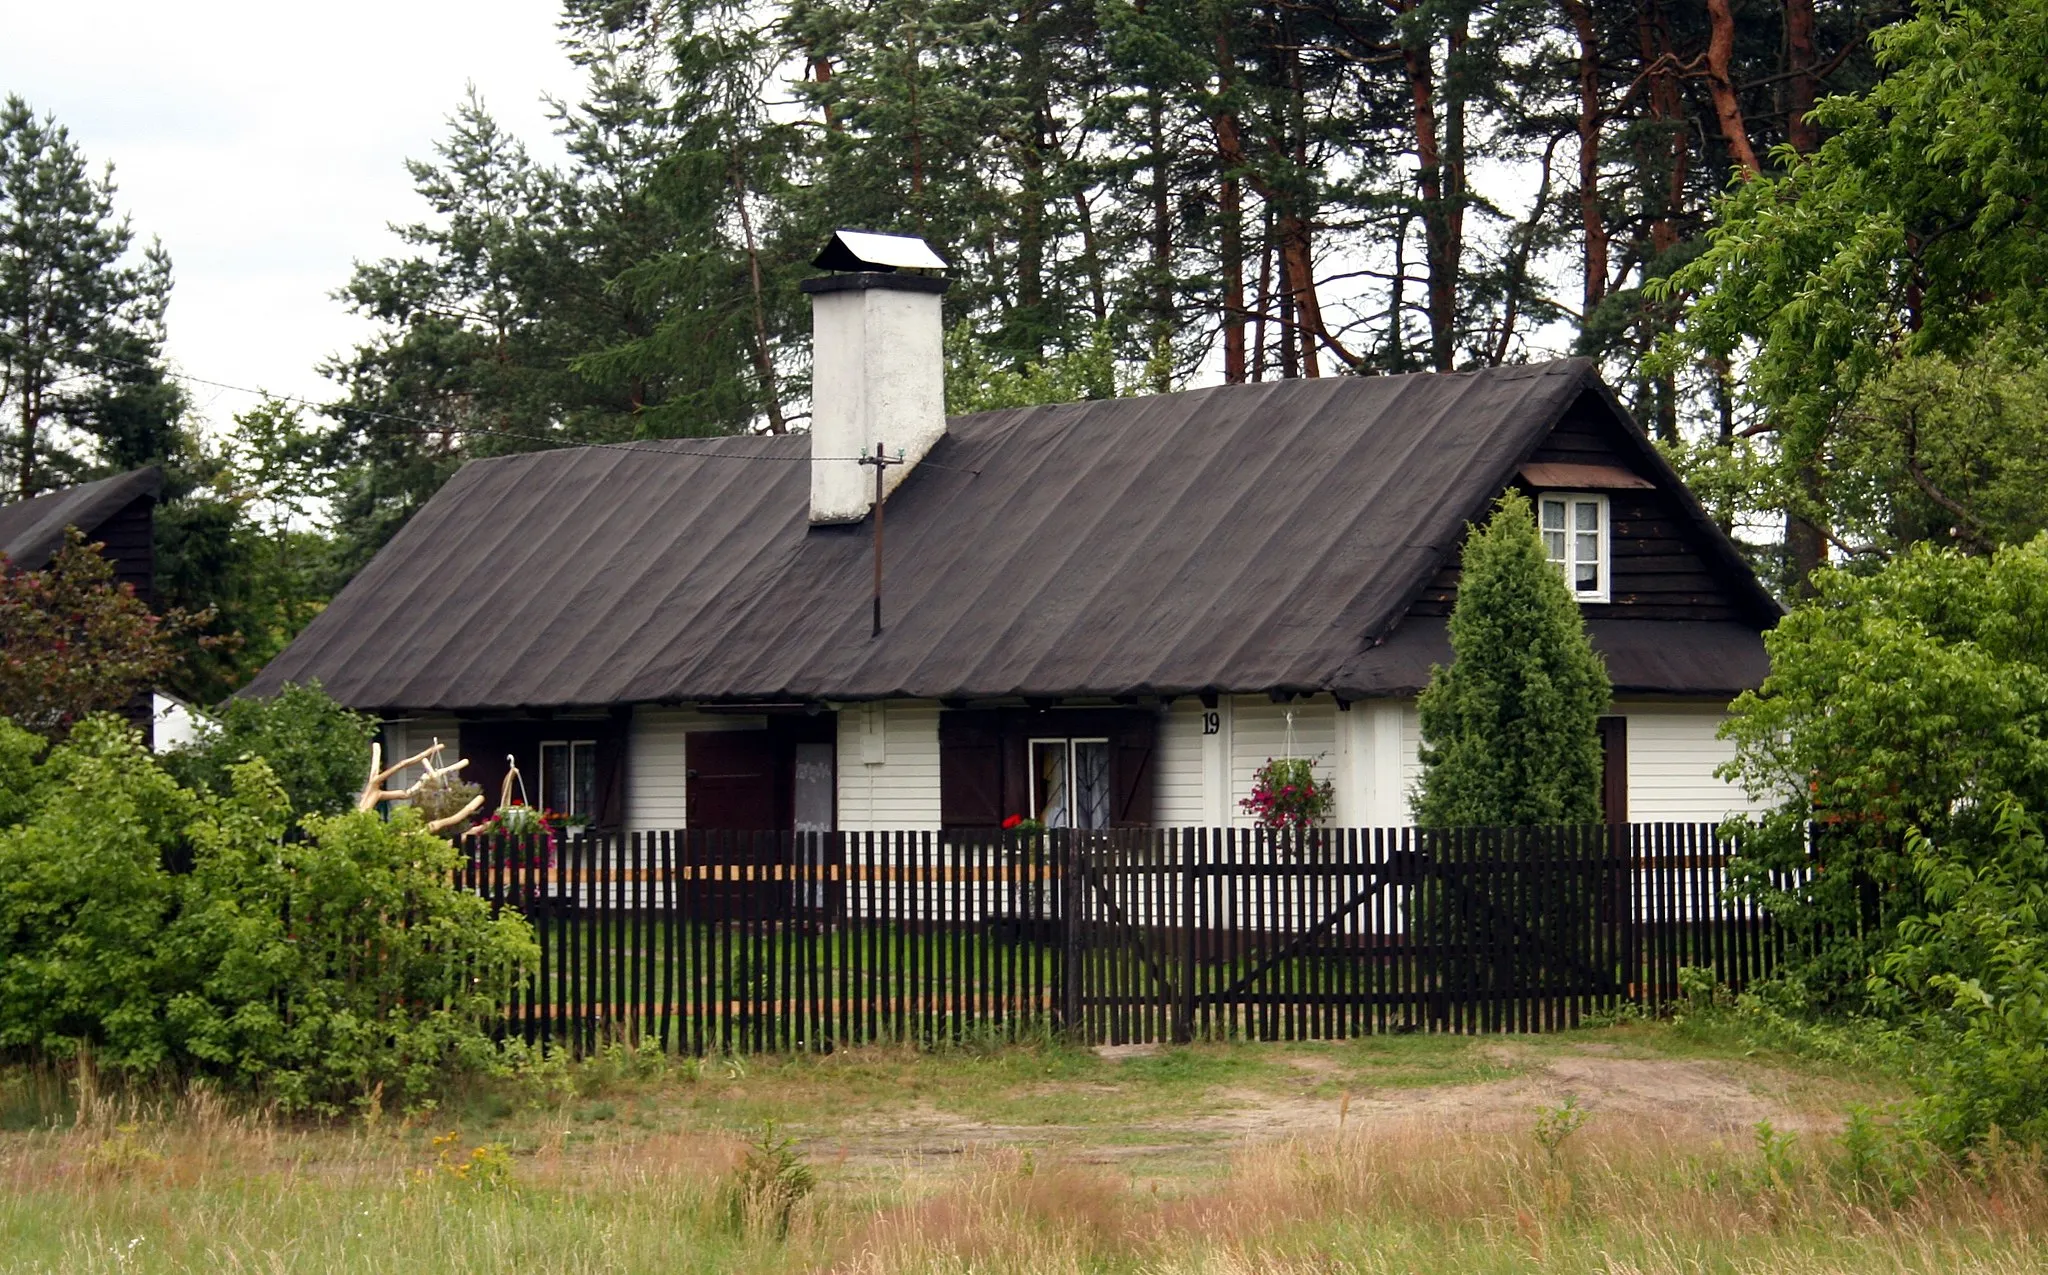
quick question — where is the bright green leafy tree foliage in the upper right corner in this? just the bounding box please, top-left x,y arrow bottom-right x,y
1667,0 -> 2048,575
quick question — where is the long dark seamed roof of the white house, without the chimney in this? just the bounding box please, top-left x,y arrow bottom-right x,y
246,360 -> 1776,712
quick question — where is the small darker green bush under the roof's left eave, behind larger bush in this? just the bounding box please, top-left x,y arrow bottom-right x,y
164,684 -> 377,815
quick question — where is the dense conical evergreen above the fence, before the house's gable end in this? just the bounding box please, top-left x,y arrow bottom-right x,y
1415,491 -> 1612,827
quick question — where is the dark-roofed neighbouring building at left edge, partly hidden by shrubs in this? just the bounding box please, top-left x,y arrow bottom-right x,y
0,465 -> 203,747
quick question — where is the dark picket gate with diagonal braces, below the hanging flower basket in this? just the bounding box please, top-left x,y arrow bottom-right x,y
1059,827 -> 1630,1044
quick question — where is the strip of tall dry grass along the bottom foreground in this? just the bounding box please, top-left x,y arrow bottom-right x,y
0,1074 -> 2048,1275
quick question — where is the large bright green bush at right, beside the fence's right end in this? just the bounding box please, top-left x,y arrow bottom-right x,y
1724,536 -> 2048,1152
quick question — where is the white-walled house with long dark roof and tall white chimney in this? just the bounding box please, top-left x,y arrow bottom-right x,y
244,233 -> 1780,831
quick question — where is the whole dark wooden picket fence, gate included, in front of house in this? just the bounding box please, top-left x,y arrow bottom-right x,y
465,825 -> 1782,1052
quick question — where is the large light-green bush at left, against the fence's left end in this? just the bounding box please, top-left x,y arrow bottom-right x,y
0,718 -> 535,1111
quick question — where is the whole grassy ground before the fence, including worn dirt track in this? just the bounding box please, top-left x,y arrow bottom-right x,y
0,1023 -> 2048,1275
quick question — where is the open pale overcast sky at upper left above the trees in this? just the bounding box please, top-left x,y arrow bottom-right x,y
0,0 -> 578,426
